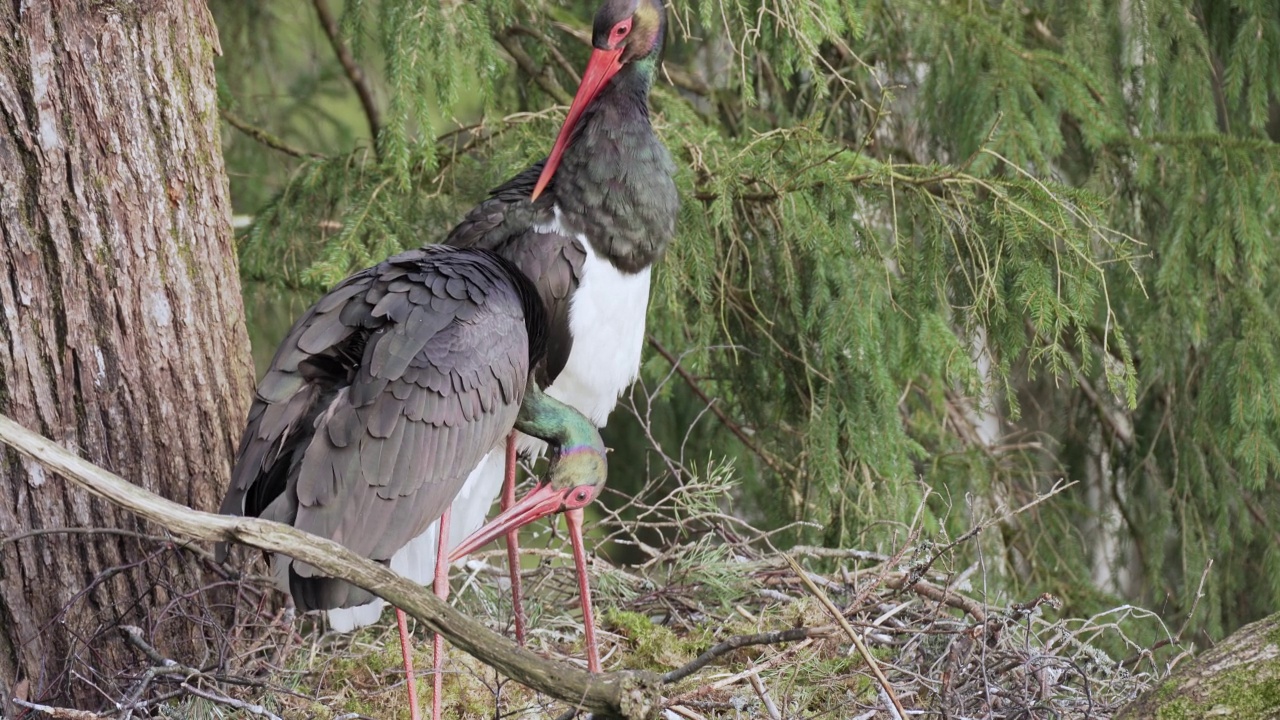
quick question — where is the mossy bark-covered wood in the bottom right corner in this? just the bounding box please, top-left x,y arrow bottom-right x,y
1116,614 -> 1280,720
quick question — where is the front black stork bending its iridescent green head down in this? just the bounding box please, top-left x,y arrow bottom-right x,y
219,246 -> 605,720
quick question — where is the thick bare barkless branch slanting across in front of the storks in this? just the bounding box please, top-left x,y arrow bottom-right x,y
0,415 -> 660,719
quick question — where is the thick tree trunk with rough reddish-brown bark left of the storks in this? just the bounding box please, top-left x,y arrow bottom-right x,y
0,0 -> 252,716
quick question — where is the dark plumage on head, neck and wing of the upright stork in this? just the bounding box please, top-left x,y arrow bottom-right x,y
444,0 -> 680,386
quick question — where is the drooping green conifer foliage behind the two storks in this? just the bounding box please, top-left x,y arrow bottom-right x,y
212,0 -> 1280,634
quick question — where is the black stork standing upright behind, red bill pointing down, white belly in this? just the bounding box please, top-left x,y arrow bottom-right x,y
329,0 -> 680,671
